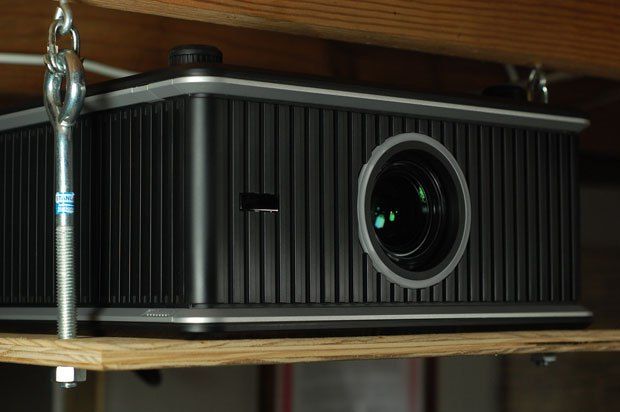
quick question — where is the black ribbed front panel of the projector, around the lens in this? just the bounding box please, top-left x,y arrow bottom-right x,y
190,97 -> 578,305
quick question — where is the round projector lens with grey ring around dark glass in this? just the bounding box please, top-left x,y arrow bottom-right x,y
357,133 -> 471,288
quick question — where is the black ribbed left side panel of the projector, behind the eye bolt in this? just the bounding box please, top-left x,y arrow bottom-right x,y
0,98 -> 187,307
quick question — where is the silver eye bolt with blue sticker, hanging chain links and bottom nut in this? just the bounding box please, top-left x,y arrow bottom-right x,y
43,1 -> 86,388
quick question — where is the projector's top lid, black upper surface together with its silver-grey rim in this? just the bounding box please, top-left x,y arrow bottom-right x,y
0,64 -> 589,132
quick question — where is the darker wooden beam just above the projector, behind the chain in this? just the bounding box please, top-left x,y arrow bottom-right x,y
0,0 -> 507,106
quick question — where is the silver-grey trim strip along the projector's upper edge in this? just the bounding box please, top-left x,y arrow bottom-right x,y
0,76 -> 590,132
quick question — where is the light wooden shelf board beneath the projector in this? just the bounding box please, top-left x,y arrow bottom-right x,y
0,330 -> 620,371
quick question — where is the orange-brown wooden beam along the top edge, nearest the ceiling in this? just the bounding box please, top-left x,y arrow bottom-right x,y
84,0 -> 620,78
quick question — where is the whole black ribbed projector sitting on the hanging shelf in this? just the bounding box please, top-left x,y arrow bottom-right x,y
0,47 -> 591,334
